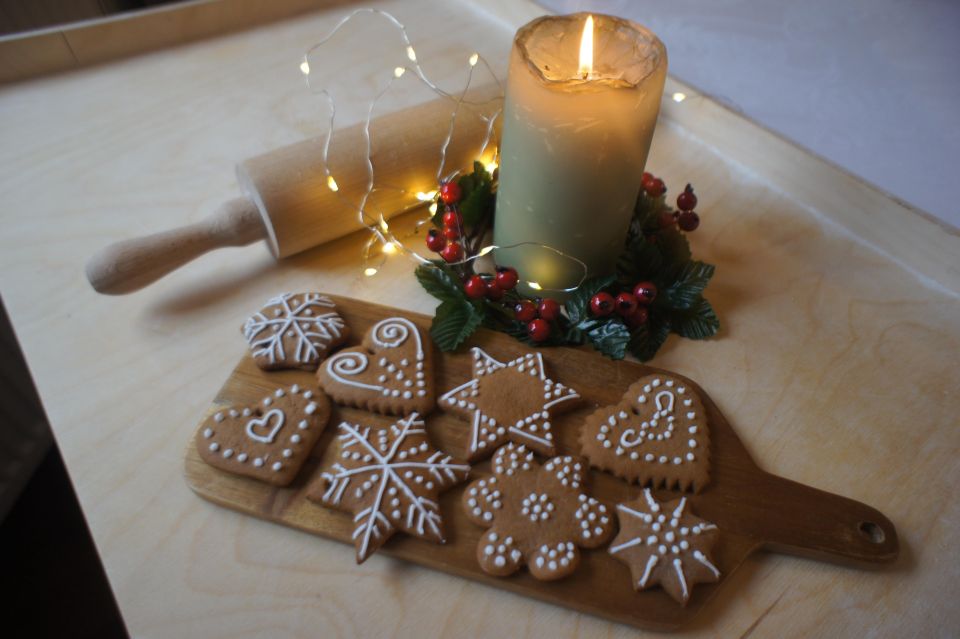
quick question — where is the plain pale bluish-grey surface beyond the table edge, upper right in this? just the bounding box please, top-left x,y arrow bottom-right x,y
539,0 -> 960,230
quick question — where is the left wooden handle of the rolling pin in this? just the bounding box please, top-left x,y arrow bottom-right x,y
86,197 -> 267,295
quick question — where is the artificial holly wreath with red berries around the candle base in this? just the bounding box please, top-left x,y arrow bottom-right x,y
416,162 -> 720,361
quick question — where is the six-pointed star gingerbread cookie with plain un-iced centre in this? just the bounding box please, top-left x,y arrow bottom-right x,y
440,348 -> 580,461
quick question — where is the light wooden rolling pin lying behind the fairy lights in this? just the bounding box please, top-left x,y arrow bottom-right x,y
86,85 -> 499,295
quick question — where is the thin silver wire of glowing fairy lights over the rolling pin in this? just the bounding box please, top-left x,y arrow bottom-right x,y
300,8 -> 587,292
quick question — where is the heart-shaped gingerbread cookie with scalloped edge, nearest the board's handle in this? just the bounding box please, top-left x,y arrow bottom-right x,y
580,373 -> 710,492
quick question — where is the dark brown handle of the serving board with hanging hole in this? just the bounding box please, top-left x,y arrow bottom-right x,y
753,473 -> 900,568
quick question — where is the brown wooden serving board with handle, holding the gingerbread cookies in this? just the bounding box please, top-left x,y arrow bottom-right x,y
185,296 -> 899,630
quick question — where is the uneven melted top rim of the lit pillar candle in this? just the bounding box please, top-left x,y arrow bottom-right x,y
514,11 -> 667,92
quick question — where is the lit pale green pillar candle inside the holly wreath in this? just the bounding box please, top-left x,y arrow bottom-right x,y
494,14 -> 667,292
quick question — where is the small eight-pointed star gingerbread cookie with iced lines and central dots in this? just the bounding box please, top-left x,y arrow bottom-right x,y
610,488 -> 720,605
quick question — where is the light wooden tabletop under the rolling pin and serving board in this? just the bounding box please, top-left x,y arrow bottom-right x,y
0,1 -> 960,637
